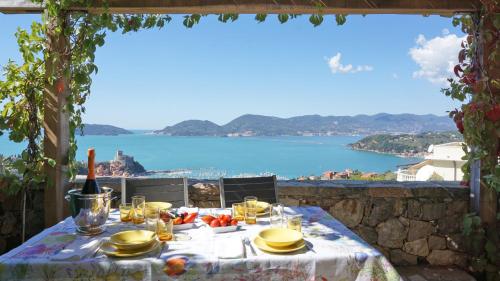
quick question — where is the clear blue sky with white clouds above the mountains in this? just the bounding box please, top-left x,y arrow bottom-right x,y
0,14 -> 463,129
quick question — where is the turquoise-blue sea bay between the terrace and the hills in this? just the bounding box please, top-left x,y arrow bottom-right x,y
0,132 -> 419,179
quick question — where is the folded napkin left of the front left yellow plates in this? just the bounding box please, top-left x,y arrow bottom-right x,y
50,237 -> 101,261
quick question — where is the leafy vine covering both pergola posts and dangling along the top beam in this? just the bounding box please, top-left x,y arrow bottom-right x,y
0,0 -> 500,274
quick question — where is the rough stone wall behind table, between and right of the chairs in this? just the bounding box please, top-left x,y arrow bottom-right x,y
189,181 -> 469,267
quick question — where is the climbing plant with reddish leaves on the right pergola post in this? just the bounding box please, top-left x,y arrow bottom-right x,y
442,0 -> 500,280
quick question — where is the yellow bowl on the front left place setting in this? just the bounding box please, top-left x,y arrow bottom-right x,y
110,230 -> 156,250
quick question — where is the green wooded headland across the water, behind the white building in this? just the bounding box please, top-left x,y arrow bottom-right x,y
350,132 -> 463,155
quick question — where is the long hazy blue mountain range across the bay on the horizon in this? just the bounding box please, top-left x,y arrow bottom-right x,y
154,113 -> 455,136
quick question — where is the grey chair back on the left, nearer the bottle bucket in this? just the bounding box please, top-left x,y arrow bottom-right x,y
122,178 -> 189,208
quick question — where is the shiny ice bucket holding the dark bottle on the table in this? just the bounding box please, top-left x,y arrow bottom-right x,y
65,187 -> 115,235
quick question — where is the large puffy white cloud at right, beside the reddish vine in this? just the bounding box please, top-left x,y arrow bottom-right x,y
409,33 -> 465,85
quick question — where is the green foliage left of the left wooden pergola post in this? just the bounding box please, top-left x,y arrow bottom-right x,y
0,22 -> 47,194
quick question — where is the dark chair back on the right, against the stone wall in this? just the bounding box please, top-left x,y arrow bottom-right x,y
219,176 -> 278,208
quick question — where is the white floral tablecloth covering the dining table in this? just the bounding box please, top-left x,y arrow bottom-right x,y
0,207 -> 401,281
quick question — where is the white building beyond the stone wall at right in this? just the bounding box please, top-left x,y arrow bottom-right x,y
397,142 -> 465,181
